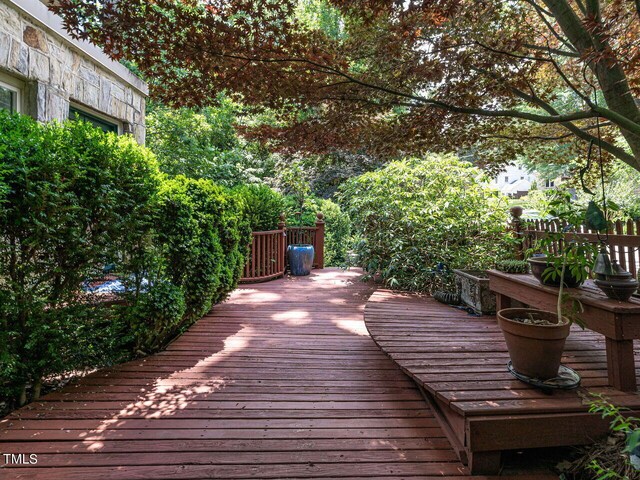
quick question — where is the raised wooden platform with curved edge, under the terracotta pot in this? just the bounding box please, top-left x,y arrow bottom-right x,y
365,290 -> 640,472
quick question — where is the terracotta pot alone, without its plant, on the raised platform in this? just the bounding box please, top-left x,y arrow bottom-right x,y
498,308 -> 571,380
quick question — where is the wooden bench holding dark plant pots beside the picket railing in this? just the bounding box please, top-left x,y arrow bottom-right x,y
489,270 -> 640,392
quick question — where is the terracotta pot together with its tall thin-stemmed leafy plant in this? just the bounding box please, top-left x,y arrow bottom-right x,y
498,192 -> 606,380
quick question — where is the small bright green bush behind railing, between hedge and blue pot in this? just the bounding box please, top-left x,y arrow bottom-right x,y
233,185 -> 284,232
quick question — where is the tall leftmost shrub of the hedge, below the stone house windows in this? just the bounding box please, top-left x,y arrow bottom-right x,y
0,112 -> 159,403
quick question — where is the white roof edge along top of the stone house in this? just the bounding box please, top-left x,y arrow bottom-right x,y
5,0 -> 149,96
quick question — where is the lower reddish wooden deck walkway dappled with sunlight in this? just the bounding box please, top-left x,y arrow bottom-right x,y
0,270 -> 552,480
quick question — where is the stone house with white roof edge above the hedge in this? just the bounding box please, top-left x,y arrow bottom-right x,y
0,0 -> 148,144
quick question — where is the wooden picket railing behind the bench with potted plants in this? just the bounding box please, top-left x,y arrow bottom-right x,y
511,209 -> 640,278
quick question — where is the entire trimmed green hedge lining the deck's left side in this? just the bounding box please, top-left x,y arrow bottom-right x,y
0,111 -> 251,404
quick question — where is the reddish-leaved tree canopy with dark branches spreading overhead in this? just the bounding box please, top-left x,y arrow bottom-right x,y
52,0 -> 640,170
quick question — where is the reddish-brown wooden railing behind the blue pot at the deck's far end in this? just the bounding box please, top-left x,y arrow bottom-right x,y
240,213 -> 324,283
